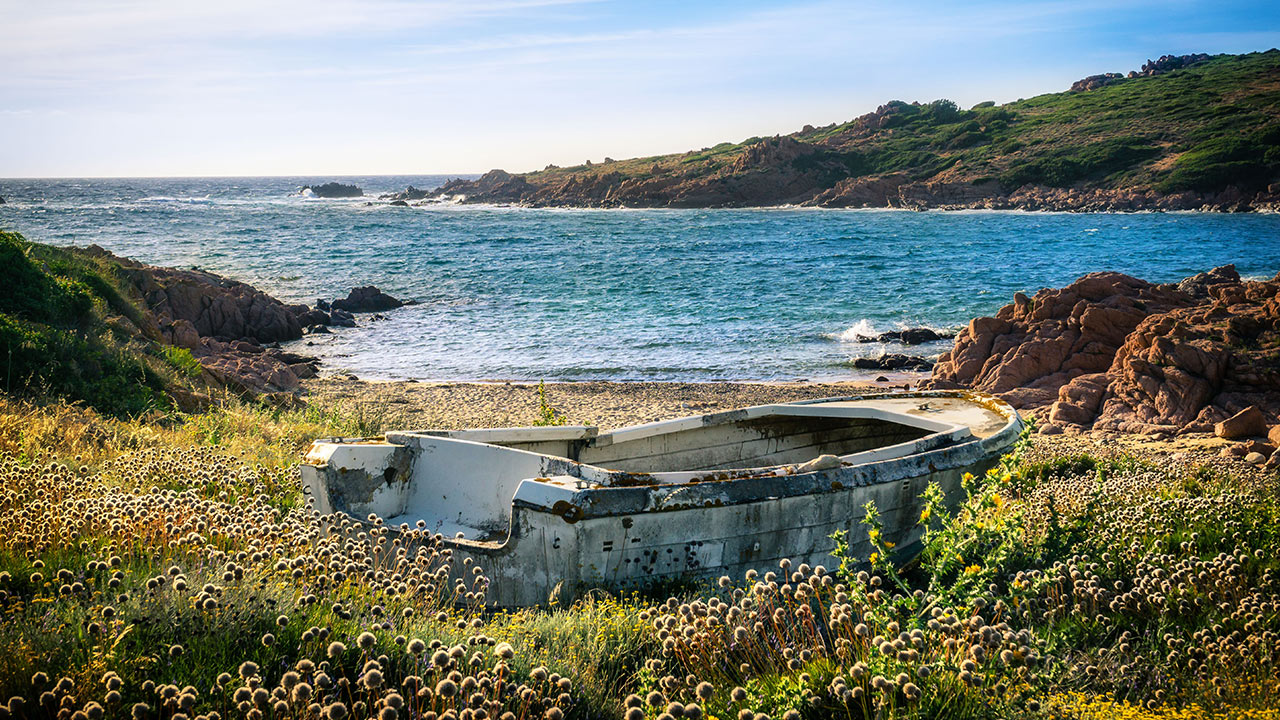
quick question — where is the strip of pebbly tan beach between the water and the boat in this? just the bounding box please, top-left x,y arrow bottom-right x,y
303,375 -> 911,429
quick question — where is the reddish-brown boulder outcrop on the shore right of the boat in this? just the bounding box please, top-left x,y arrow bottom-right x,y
922,265 -> 1280,466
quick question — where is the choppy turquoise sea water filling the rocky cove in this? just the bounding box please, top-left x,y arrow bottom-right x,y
0,176 -> 1280,380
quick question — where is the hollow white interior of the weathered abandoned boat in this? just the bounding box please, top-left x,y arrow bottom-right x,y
368,401 -> 973,541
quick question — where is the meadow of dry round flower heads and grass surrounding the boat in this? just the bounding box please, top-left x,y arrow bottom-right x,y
0,397 -> 1280,720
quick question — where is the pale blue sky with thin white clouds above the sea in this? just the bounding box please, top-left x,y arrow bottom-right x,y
0,0 -> 1280,177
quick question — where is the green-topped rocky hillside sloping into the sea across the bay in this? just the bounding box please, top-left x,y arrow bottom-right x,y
426,50 -> 1280,211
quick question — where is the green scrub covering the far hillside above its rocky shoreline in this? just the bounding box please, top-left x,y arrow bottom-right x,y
525,50 -> 1280,192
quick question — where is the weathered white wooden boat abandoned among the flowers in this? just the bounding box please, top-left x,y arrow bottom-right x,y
302,391 -> 1023,607
